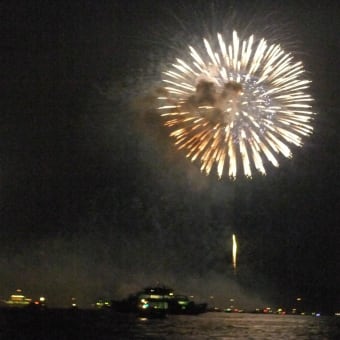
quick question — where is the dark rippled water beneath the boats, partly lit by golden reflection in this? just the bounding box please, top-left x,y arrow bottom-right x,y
0,310 -> 340,340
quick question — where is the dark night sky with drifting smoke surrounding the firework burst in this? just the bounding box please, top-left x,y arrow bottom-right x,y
0,0 -> 340,311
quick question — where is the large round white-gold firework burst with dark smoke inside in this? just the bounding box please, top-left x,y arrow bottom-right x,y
158,31 -> 313,178
